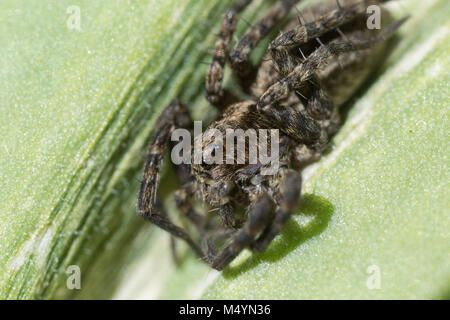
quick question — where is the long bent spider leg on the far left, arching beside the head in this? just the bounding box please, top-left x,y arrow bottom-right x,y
137,100 -> 205,259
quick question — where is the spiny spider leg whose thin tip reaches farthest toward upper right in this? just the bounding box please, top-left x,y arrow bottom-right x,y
257,17 -> 408,112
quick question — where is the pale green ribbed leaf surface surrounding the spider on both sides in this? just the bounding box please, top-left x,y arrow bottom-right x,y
0,0 -> 450,299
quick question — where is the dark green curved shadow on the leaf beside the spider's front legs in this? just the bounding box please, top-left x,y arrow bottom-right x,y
222,194 -> 334,279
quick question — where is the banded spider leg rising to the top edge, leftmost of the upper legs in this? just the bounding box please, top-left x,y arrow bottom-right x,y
206,0 -> 252,108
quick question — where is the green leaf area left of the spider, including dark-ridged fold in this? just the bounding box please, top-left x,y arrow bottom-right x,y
0,0 -> 243,299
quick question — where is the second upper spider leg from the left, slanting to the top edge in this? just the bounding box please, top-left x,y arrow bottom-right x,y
230,0 -> 299,77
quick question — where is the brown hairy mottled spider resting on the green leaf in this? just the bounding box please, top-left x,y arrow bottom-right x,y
137,0 -> 406,270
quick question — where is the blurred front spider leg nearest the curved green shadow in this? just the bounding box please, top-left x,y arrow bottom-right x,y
250,169 -> 302,252
